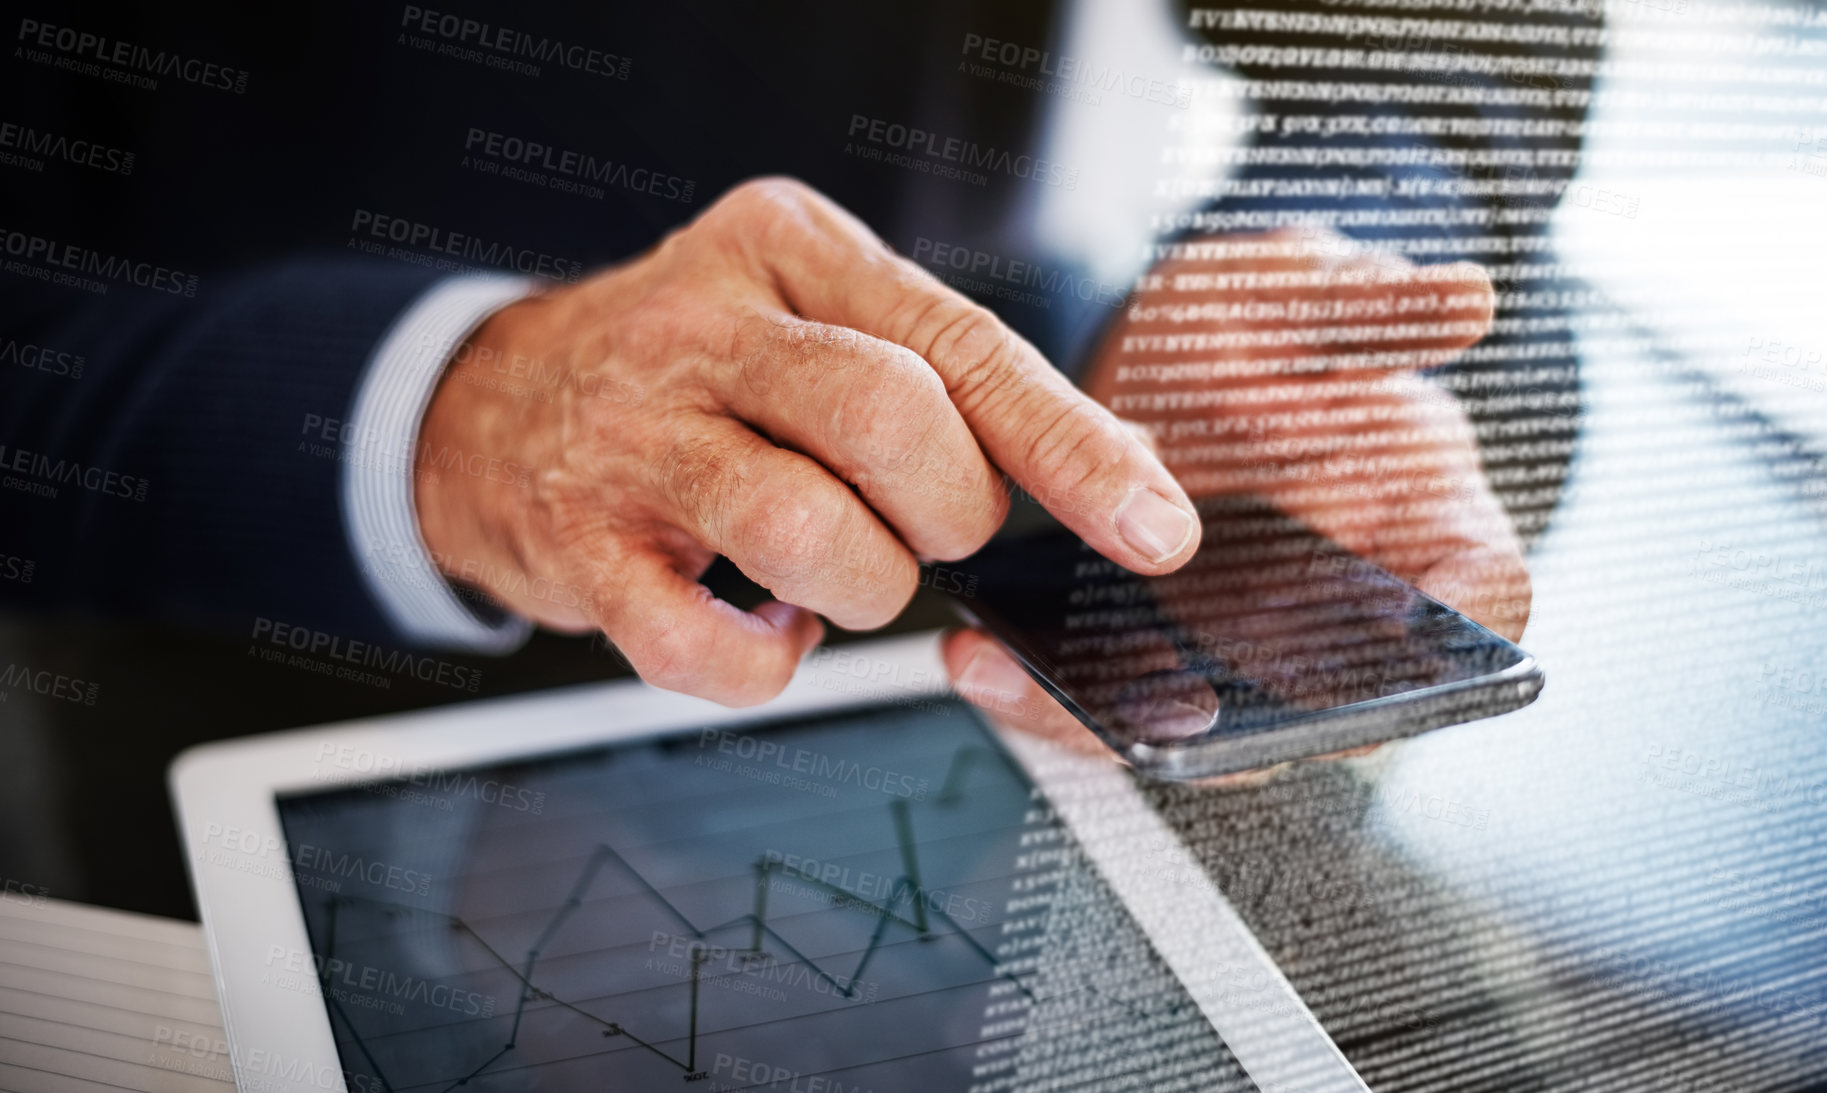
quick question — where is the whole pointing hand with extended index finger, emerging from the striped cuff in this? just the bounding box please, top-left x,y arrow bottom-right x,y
415,179 -> 1199,706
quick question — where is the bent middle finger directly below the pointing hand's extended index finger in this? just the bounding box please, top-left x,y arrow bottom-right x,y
725,314 -> 1009,561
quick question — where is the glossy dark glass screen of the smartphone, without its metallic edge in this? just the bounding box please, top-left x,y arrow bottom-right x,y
957,497 -> 1526,742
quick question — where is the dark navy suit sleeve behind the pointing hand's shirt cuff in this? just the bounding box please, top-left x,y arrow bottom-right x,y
0,258 -> 449,638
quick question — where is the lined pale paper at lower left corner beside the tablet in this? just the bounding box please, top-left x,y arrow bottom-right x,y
0,892 -> 234,1093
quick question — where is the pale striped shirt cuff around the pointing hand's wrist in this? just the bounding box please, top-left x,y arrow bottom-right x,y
342,276 -> 533,653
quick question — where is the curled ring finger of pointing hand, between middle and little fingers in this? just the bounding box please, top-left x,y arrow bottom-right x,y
652,417 -> 919,629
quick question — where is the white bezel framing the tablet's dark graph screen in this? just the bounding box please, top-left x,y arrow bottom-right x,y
170,634 -> 1367,1093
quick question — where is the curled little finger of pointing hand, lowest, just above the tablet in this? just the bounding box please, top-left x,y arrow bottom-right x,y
599,550 -> 824,706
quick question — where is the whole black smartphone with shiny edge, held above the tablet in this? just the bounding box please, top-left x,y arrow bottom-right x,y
923,497 -> 1542,779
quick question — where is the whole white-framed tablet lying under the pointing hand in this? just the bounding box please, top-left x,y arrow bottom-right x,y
172,634 -> 1365,1093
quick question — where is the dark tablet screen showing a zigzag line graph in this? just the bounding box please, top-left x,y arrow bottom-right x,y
277,698 -> 1255,1093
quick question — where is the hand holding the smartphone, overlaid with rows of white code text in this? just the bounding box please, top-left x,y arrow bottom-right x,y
945,228 -> 1529,780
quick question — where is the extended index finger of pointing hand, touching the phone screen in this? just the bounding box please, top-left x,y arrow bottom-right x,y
719,183 -> 1199,574
